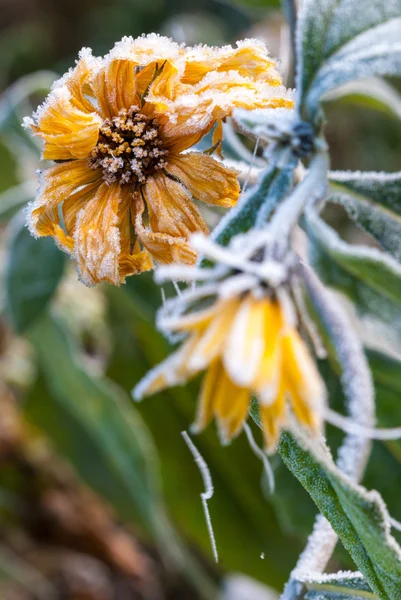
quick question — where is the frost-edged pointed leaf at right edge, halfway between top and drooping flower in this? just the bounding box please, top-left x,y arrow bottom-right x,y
330,171 -> 401,260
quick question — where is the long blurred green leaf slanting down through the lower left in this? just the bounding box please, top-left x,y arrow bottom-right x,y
24,315 -> 219,598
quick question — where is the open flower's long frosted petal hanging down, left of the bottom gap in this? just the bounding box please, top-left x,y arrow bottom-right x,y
75,183 -> 121,285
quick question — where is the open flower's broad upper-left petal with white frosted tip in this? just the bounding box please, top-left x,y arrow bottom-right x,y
28,86 -> 102,160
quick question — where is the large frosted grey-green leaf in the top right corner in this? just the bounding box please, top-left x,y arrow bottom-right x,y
297,0 -> 401,120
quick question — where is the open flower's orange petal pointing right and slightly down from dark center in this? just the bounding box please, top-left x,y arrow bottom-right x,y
166,152 -> 240,208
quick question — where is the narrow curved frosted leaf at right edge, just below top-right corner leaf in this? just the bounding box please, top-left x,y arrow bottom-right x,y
322,77 -> 401,119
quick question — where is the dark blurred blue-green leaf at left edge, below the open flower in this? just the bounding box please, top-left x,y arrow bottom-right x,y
5,218 -> 66,333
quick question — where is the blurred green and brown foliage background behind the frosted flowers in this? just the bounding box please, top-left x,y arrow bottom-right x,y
0,0 -> 401,600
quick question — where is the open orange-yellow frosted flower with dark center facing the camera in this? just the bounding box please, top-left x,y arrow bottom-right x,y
26,34 -> 292,285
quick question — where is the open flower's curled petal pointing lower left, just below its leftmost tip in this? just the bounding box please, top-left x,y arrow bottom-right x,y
28,160 -> 101,236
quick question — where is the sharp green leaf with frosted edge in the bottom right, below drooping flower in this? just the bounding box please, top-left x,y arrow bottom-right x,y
279,432 -> 401,600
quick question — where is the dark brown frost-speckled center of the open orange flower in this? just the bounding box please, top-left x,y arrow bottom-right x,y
89,106 -> 168,184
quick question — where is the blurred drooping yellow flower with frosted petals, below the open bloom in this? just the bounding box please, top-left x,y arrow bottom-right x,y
134,288 -> 325,451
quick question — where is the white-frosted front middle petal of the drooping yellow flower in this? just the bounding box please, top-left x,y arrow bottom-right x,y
224,294 -> 268,387
